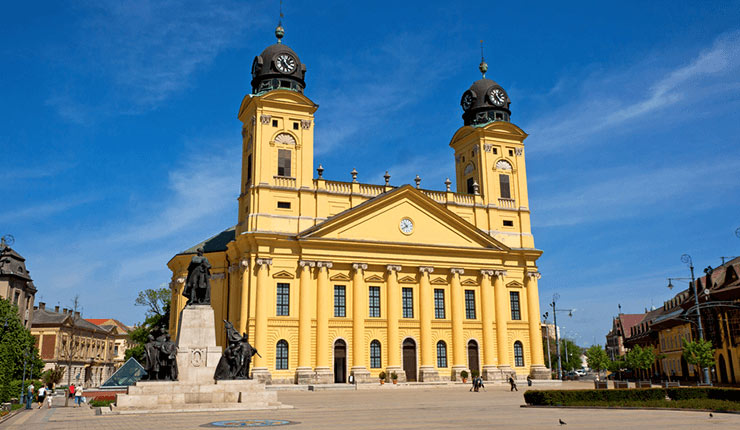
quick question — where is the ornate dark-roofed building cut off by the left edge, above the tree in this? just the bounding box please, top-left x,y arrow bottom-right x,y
0,237 -> 36,329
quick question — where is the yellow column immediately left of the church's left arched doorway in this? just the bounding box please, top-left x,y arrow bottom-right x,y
316,261 -> 334,384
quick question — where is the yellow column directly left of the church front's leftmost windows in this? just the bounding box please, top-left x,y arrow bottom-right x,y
252,258 -> 273,382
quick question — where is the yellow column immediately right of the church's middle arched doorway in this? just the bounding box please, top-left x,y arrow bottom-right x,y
419,266 -> 439,382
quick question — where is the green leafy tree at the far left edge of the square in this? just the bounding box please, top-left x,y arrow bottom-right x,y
0,299 -> 44,402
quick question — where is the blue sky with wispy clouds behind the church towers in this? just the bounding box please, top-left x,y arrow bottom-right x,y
0,0 -> 740,344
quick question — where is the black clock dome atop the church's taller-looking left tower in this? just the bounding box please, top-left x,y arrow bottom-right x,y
252,42 -> 306,94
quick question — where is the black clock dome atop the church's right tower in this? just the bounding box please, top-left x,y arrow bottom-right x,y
460,78 -> 511,125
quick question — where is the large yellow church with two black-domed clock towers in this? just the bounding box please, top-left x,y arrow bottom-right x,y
168,27 -> 549,384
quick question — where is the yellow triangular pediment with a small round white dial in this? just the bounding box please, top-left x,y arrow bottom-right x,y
298,185 -> 508,250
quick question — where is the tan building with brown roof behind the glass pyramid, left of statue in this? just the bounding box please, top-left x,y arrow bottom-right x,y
31,302 -> 119,387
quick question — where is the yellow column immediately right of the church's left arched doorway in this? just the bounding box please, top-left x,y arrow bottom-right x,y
351,263 -> 370,383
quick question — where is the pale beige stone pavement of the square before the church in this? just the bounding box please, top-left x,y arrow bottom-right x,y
2,383 -> 740,430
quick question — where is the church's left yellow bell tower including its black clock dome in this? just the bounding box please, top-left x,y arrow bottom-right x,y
237,25 -> 318,234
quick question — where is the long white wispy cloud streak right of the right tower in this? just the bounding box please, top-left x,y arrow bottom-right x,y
527,32 -> 740,156
